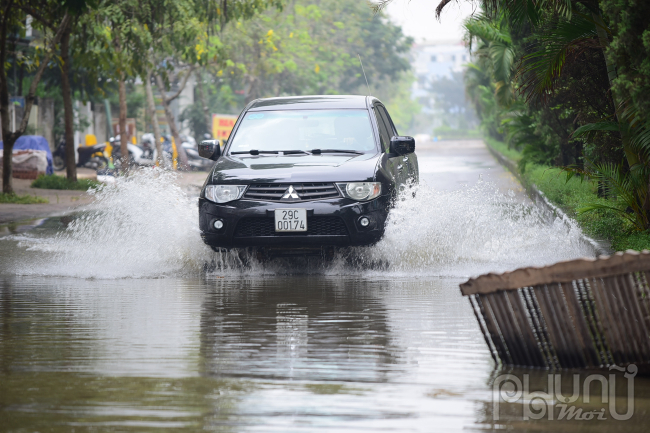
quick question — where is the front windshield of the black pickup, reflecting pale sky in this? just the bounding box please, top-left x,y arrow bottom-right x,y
230,110 -> 376,153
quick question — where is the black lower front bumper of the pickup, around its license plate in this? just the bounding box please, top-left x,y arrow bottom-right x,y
199,196 -> 390,248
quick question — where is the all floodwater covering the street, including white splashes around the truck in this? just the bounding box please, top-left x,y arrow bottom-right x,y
0,142 -> 650,432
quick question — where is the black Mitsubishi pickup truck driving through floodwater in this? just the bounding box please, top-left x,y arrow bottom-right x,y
199,96 -> 418,255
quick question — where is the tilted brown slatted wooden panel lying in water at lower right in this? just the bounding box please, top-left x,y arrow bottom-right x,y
460,251 -> 650,372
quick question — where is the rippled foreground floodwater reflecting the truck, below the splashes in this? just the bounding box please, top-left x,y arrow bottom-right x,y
0,277 -> 491,431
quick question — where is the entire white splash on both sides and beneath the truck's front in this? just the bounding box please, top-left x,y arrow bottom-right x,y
6,169 -> 591,278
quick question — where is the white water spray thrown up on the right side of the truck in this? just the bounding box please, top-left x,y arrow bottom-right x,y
354,181 -> 591,276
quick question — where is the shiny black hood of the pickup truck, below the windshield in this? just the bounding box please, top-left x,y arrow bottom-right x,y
210,153 -> 381,185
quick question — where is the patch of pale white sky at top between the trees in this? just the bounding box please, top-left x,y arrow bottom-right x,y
387,0 -> 475,42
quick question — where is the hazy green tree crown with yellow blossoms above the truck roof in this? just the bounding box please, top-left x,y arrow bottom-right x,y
213,0 -> 412,102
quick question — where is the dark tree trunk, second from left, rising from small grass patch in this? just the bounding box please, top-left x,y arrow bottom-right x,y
61,21 -> 77,182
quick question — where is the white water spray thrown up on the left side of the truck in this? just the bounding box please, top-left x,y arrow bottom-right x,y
17,169 -> 211,278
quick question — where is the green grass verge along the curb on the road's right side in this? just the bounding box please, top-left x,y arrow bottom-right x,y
485,138 -> 650,251
